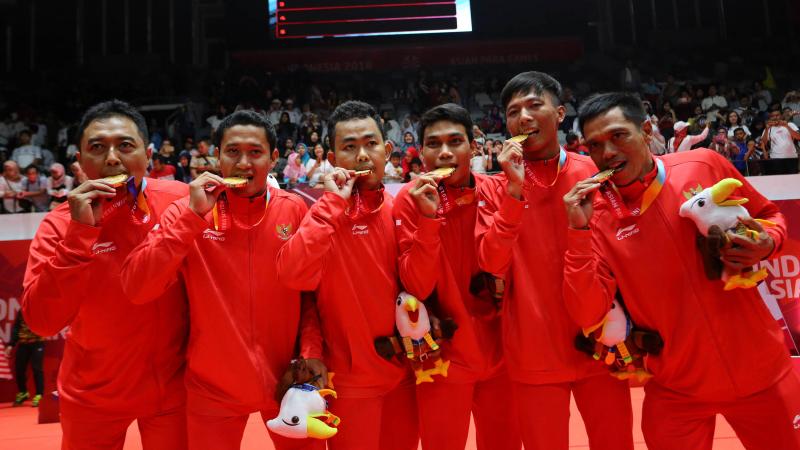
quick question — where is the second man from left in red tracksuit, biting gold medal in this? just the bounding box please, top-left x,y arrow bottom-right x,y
122,110 -> 324,450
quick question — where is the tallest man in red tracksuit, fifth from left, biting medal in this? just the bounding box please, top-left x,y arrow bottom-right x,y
476,72 -> 633,450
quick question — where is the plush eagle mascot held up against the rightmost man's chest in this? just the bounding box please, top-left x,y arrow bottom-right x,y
680,178 -> 775,291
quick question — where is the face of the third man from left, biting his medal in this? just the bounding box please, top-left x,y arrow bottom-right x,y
333,117 -> 392,190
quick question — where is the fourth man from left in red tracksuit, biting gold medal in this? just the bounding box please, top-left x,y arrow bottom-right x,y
393,103 -> 522,450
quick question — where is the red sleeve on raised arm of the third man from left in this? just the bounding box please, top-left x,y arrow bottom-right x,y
278,192 -> 347,291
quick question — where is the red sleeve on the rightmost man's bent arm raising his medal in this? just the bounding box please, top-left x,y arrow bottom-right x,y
563,228 -> 617,328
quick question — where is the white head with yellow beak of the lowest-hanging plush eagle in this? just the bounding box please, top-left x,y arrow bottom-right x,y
267,384 -> 340,439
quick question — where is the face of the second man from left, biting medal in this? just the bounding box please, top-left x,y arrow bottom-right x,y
219,125 -> 277,197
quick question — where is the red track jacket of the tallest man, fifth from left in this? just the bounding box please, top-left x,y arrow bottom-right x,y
475,153 -> 607,384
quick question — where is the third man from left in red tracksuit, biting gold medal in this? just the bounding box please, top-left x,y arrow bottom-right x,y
278,101 -> 418,450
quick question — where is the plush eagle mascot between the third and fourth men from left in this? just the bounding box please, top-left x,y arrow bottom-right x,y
375,292 -> 455,384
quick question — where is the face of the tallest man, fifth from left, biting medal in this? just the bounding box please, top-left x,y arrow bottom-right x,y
500,92 -> 566,155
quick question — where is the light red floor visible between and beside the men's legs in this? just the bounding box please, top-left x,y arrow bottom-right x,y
0,388 -> 744,450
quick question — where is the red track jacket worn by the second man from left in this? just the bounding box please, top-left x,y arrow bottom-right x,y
122,189 -> 321,416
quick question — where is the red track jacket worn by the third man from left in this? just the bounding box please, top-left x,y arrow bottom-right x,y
278,191 -> 410,398
